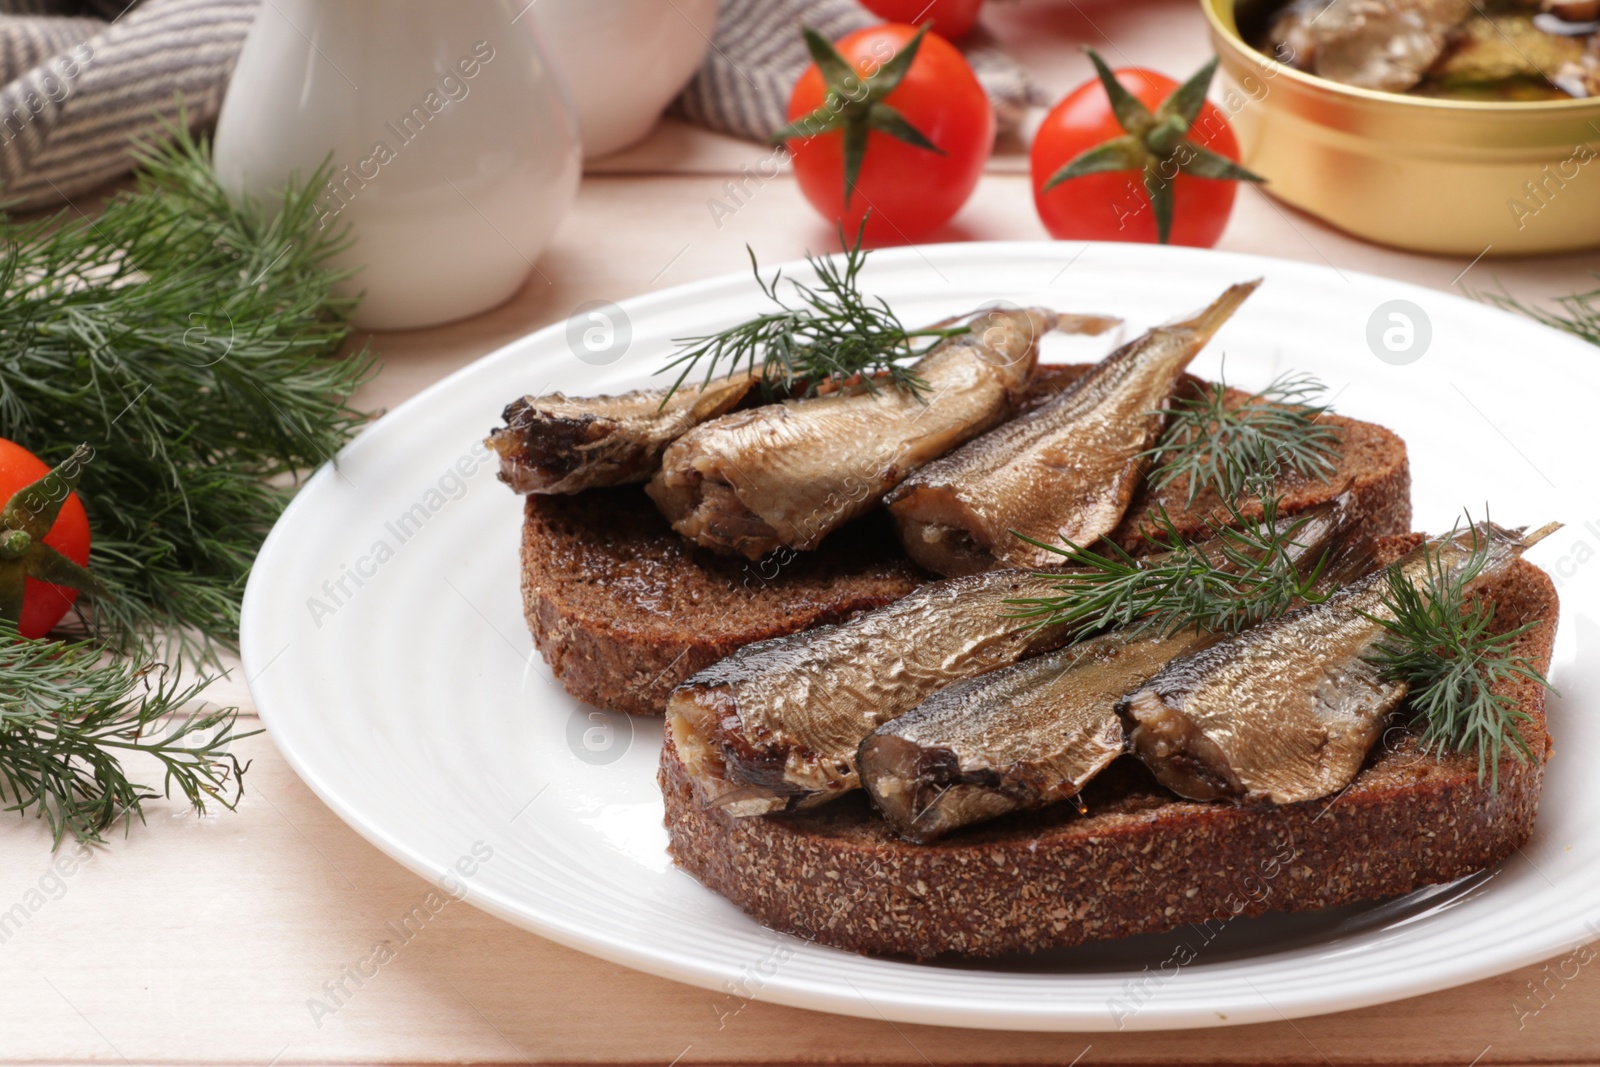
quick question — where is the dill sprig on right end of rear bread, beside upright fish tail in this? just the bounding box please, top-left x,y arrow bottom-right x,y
1146,374 -> 1339,506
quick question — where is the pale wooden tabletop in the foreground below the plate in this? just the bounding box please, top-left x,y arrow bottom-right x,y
0,736 -> 1600,1065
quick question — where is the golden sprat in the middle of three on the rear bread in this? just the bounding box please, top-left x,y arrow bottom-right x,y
646,309 -> 1056,560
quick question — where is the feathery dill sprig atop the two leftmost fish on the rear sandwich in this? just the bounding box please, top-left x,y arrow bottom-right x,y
662,221 -> 968,403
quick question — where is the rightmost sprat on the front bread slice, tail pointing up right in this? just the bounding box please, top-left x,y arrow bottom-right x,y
1118,523 -> 1552,805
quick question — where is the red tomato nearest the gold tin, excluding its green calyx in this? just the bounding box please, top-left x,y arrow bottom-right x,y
1032,67 -> 1238,248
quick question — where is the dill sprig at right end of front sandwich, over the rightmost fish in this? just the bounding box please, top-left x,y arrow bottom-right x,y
1368,528 -> 1550,787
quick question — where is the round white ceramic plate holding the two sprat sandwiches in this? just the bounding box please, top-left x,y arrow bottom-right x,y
243,243 -> 1600,1030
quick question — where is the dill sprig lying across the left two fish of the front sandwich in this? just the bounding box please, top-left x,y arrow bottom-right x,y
1006,498 -> 1326,635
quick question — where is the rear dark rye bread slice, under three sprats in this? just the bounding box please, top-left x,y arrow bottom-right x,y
522,366 -> 1411,715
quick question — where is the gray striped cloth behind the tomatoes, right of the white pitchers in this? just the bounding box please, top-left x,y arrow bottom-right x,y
674,0 -> 1050,141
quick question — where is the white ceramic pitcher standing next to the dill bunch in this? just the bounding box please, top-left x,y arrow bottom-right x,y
214,0 -> 581,330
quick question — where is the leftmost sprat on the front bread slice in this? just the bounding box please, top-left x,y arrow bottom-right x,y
667,571 -> 1066,816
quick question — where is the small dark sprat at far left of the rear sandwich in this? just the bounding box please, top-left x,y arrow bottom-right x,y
486,371 -> 760,493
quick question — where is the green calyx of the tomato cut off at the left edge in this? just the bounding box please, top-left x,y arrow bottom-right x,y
0,445 -> 106,625
